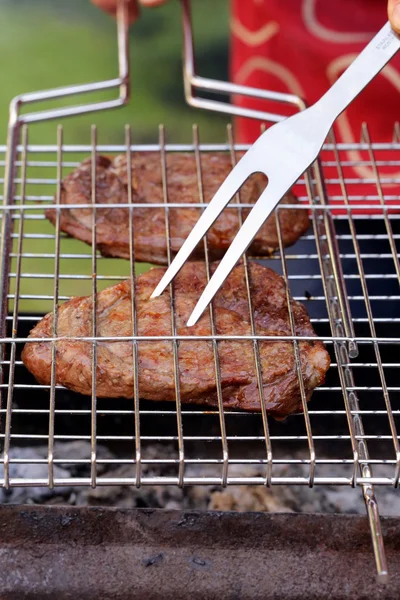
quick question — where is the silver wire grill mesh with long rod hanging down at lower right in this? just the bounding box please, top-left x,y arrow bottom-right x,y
0,126 -> 400,581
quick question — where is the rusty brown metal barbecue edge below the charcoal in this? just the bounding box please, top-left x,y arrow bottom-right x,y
0,506 -> 400,600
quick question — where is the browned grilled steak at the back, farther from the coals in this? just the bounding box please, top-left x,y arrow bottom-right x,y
46,152 -> 309,265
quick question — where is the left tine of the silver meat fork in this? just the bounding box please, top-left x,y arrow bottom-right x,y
151,148 -> 254,298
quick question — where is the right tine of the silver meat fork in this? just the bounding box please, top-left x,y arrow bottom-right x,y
187,178 -> 294,327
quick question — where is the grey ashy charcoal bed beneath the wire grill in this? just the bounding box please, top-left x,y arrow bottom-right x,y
0,441 -> 400,516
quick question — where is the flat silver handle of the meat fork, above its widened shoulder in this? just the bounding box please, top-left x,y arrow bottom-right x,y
317,21 -> 400,122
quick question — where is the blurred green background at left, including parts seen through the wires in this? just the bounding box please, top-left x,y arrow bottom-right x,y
0,0 -> 229,314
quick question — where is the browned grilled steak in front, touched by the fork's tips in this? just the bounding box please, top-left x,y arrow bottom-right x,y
22,262 -> 330,418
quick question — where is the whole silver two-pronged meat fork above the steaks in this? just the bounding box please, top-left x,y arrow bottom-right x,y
151,22 -> 400,327
